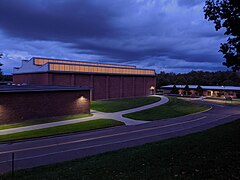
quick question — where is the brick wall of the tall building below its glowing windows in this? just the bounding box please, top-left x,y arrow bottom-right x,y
13,73 -> 156,100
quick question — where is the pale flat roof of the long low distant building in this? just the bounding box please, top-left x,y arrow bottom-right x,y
161,85 -> 240,91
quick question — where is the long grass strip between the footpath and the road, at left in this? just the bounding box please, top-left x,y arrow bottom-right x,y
0,119 -> 124,142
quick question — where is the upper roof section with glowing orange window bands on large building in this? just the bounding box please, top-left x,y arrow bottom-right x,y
13,57 -> 156,76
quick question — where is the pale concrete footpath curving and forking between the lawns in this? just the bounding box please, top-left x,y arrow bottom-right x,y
0,95 -> 169,135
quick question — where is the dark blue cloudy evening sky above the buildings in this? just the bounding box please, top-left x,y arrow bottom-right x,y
0,0 -> 229,73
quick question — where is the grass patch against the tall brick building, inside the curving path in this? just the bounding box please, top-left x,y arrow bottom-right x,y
91,96 -> 160,112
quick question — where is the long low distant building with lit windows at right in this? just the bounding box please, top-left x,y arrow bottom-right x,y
160,85 -> 240,98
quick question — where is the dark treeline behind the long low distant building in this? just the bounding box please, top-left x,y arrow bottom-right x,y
157,71 -> 240,88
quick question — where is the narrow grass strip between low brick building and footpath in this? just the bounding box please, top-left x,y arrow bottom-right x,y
0,114 -> 92,130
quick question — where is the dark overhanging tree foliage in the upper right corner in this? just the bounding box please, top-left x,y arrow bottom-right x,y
204,0 -> 240,71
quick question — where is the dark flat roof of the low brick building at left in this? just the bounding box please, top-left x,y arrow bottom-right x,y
0,85 -> 92,93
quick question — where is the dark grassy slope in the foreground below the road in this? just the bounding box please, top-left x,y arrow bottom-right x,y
0,120 -> 240,180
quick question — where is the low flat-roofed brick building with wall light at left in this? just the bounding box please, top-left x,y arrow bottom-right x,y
0,85 -> 90,124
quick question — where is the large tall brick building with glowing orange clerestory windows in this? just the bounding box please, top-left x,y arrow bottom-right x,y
13,57 -> 156,100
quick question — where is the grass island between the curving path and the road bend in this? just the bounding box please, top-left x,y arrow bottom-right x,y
123,97 -> 209,121
